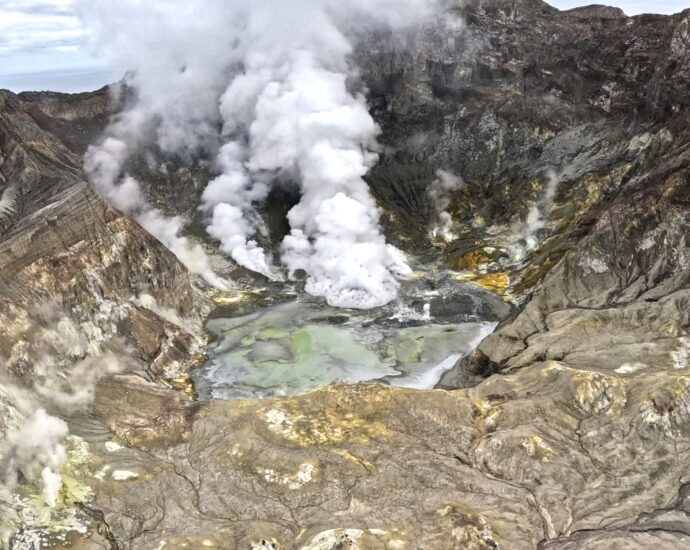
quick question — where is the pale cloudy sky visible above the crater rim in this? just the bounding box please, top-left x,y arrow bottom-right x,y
0,0 -> 690,92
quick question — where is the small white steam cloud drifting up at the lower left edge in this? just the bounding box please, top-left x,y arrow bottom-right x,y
0,303 -> 125,520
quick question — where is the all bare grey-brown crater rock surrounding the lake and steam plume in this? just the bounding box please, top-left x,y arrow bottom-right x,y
0,0 -> 690,549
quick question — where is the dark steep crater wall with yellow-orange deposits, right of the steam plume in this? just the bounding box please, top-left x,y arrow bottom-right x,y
355,0 -> 690,295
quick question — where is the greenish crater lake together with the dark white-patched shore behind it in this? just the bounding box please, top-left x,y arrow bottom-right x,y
192,273 -> 508,400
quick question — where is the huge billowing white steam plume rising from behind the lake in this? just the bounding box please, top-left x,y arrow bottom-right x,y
75,0 -> 434,308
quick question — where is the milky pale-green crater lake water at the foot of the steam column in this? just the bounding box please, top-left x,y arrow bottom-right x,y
193,299 -> 495,399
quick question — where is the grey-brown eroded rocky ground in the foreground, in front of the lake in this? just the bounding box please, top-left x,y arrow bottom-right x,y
64,368 -> 690,549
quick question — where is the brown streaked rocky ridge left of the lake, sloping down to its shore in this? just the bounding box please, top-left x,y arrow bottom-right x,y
0,88 -> 210,381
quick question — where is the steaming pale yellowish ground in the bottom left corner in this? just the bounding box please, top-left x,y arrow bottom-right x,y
0,352 -> 126,548
